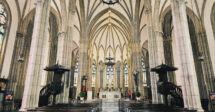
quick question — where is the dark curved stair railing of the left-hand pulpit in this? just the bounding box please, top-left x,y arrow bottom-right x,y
39,82 -> 63,107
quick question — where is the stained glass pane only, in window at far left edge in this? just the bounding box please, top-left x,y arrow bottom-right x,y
0,3 -> 7,52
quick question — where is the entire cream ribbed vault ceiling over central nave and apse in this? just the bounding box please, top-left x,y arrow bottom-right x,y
74,0 -> 144,61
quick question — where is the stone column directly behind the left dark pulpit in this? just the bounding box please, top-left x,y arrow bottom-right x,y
57,0 -> 76,103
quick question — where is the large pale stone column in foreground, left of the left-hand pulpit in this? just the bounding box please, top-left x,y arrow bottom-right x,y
20,0 -> 51,111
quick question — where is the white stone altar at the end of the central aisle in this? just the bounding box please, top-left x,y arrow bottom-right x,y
99,91 -> 121,101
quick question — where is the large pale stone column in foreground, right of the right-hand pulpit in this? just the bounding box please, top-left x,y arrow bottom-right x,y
171,0 -> 203,112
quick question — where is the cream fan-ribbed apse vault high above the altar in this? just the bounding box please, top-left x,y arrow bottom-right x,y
91,10 -> 129,54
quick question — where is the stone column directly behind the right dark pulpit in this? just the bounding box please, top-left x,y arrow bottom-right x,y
145,0 -> 163,104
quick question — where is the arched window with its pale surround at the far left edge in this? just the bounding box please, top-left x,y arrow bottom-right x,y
0,2 -> 9,69
